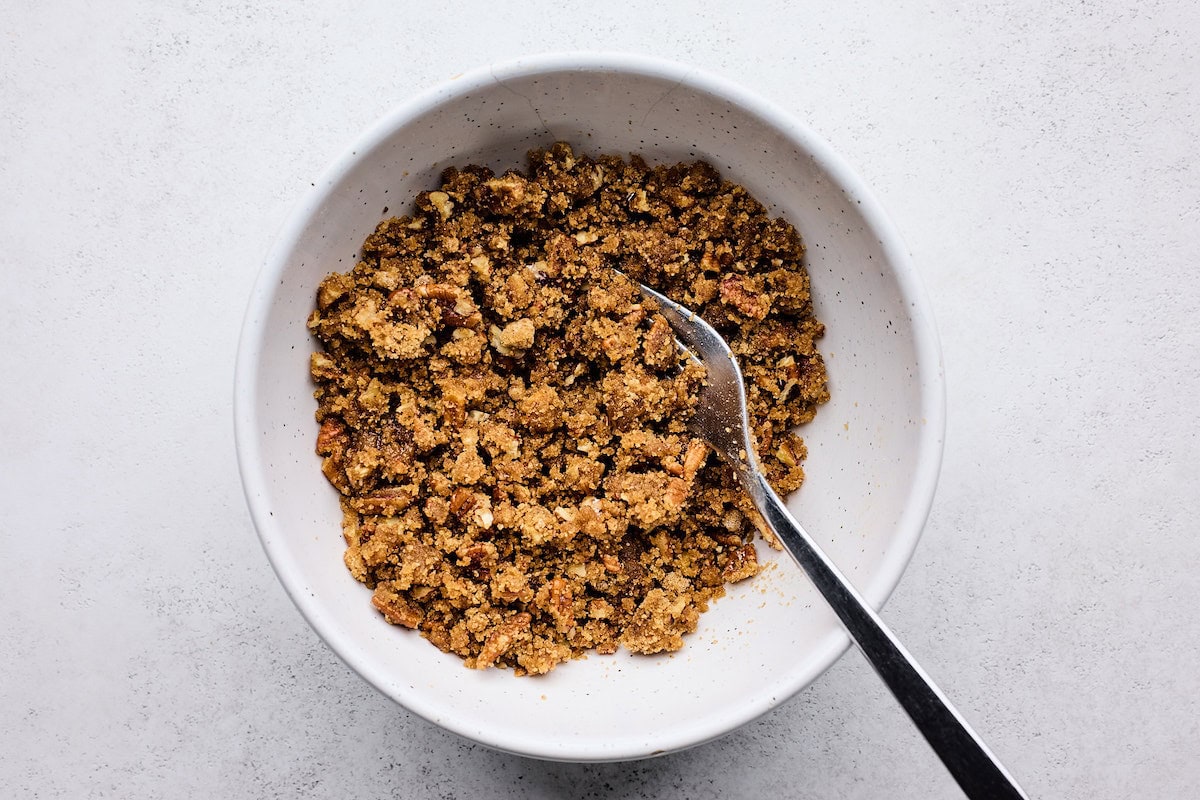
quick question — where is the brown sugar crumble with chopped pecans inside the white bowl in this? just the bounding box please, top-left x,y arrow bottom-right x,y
308,143 -> 829,674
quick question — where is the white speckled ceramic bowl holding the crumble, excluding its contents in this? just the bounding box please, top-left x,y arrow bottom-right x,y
235,54 -> 944,760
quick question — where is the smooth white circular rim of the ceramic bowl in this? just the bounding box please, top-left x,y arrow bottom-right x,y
233,50 -> 946,762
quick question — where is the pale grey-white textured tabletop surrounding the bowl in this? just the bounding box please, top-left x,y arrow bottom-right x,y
0,0 -> 1200,799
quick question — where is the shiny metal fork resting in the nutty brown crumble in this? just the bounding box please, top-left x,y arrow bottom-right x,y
640,284 -> 1027,800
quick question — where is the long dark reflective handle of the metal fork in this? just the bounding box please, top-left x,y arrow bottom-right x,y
743,470 -> 1028,800
